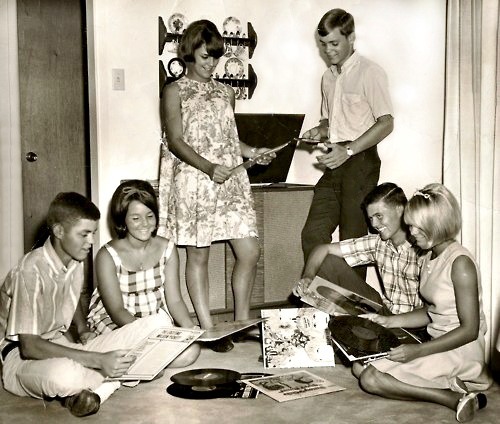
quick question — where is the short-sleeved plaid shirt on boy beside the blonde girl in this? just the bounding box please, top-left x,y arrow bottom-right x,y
340,234 -> 425,314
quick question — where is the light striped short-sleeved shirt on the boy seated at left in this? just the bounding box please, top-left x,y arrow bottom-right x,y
0,238 -> 83,350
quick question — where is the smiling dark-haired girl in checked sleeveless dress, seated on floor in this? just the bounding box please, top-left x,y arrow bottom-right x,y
87,180 -> 200,367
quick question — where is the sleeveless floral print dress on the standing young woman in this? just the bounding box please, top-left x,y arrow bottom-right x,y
158,76 -> 257,247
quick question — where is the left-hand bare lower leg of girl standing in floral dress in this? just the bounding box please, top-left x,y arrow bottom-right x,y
186,246 -> 213,328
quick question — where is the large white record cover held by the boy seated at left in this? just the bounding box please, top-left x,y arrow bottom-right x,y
110,327 -> 204,380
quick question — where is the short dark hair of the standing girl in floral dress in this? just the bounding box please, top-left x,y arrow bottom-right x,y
178,19 -> 224,62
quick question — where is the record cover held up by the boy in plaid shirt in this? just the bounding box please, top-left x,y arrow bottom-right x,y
301,276 -> 382,316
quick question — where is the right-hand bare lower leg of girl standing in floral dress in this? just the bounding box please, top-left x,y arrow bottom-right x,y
230,237 -> 260,320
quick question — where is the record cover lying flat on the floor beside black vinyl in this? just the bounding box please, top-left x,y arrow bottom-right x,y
242,370 -> 345,402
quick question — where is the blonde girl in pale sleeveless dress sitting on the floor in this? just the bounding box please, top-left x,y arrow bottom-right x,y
353,184 -> 491,422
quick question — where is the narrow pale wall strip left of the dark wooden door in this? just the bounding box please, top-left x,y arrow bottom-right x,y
0,0 -> 24,285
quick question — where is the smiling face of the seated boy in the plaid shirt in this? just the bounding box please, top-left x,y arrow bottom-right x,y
366,200 -> 406,246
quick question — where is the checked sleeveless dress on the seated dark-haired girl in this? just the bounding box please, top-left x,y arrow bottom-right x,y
87,240 -> 175,334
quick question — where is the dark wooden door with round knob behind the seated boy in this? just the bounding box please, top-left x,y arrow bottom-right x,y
17,0 -> 90,251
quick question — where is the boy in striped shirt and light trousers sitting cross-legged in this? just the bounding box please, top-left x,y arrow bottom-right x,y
0,192 -> 172,417
